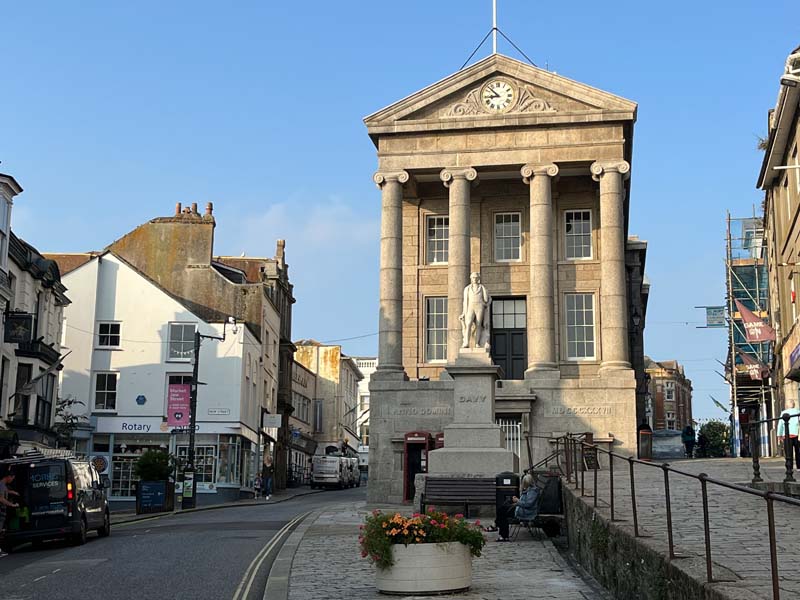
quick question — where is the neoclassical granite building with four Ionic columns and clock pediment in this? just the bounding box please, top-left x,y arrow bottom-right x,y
365,54 -> 646,501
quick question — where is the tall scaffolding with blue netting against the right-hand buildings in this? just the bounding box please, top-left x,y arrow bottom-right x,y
725,207 -> 773,457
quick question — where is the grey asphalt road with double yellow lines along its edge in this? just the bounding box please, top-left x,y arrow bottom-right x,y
0,487 -> 366,600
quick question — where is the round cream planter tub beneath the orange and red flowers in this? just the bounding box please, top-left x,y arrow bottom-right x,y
376,542 -> 472,594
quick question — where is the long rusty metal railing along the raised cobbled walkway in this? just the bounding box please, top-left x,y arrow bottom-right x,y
560,433 -> 800,600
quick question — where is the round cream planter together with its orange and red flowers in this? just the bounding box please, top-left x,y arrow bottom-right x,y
358,508 -> 486,594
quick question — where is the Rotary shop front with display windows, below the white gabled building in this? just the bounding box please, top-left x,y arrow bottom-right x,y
89,417 -> 259,508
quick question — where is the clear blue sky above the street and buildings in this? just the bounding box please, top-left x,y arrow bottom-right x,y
0,0 -> 800,417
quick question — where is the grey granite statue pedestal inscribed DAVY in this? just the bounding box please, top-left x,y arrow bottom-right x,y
428,348 -> 519,477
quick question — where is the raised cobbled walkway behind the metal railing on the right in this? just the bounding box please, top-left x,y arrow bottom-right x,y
572,459 -> 800,600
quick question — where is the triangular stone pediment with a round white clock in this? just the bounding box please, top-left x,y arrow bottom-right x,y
364,54 -> 636,134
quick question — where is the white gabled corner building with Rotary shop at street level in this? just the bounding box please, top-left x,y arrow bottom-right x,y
56,251 -> 279,503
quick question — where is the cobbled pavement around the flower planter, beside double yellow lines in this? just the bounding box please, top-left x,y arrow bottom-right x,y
289,503 -> 608,600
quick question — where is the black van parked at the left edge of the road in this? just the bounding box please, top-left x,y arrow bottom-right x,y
0,454 -> 111,552
